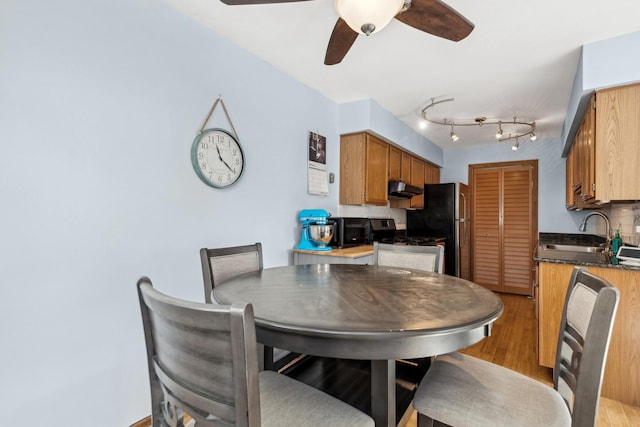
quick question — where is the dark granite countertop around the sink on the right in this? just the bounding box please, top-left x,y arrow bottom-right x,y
533,233 -> 640,271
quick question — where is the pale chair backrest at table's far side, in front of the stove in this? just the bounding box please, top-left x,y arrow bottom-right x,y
373,242 -> 444,273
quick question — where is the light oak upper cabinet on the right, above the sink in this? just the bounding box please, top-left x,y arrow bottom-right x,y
567,84 -> 640,209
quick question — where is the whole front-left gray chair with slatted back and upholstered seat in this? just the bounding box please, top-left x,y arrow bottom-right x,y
137,277 -> 374,427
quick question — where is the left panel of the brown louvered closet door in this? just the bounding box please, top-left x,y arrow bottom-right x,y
472,169 -> 502,291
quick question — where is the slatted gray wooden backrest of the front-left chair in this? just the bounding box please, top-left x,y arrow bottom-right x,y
137,277 -> 260,427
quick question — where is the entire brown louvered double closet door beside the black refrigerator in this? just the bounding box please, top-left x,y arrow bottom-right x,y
470,161 -> 538,295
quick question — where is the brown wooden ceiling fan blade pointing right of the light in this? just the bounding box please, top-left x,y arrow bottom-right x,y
396,0 -> 474,42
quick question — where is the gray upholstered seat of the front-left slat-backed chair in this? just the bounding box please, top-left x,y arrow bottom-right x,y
258,371 -> 374,427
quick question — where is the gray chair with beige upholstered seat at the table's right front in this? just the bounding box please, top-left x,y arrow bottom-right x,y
413,267 -> 620,427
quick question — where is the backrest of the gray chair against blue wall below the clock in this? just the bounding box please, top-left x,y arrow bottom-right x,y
200,243 -> 262,303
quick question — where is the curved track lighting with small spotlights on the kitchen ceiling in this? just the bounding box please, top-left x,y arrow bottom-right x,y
421,98 -> 538,151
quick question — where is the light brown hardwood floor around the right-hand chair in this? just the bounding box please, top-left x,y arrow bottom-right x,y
406,294 -> 640,427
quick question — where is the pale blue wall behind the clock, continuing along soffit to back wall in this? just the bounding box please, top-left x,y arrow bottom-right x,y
0,0 -> 620,427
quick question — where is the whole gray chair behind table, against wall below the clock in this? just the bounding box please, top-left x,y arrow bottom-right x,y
200,242 -> 297,369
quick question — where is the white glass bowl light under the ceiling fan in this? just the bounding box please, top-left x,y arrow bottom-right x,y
335,0 -> 405,36
